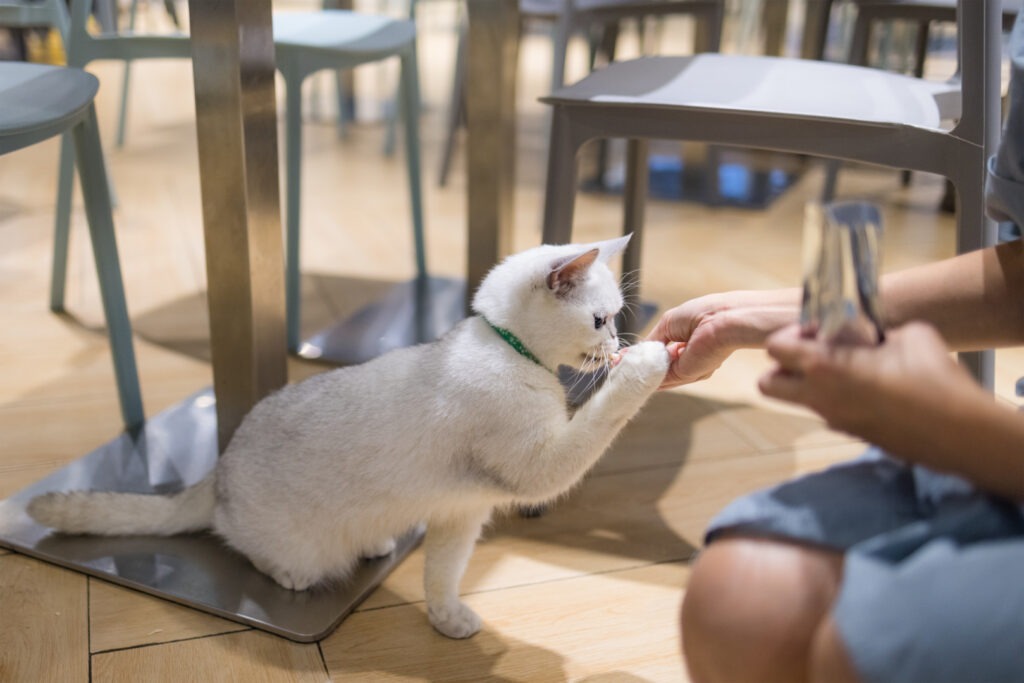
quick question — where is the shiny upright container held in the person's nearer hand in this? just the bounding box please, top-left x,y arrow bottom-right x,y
800,202 -> 885,345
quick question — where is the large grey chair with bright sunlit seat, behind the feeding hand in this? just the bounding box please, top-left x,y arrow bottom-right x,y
543,0 -> 1000,386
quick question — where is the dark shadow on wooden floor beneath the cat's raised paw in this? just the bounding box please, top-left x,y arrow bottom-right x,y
483,391 -> 821,571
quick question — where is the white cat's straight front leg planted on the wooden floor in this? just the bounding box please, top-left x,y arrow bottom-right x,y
423,510 -> 490,638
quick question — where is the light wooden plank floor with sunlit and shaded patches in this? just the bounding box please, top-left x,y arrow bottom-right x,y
0,2 -> 1024,683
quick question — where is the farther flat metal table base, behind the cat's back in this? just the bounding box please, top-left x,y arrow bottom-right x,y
298,276 -> 466,365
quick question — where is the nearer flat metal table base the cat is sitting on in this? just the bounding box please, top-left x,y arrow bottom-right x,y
0,389 -> 423,642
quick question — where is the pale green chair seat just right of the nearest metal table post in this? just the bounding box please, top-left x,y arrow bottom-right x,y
273,9 -> 416,59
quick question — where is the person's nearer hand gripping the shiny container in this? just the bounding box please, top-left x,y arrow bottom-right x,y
759,323 -> 981,447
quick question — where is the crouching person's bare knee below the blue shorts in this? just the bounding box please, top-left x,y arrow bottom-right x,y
682,536 -> 855,683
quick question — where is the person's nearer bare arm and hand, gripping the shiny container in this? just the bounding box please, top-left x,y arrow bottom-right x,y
759,323 -> 1024,501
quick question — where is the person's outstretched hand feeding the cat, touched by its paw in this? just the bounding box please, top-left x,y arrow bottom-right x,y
647,290 -> 799,389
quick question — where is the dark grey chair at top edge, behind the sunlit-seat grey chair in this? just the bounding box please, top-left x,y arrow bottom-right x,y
438,0 -> 725,186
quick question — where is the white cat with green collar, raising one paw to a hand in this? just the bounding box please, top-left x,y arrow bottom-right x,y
28,237 -> 669,638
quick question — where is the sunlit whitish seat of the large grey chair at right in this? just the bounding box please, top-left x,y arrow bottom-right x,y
542,53 -> 959,130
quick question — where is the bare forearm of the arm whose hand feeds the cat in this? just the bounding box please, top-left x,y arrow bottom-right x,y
882,242 -> 1024,351
